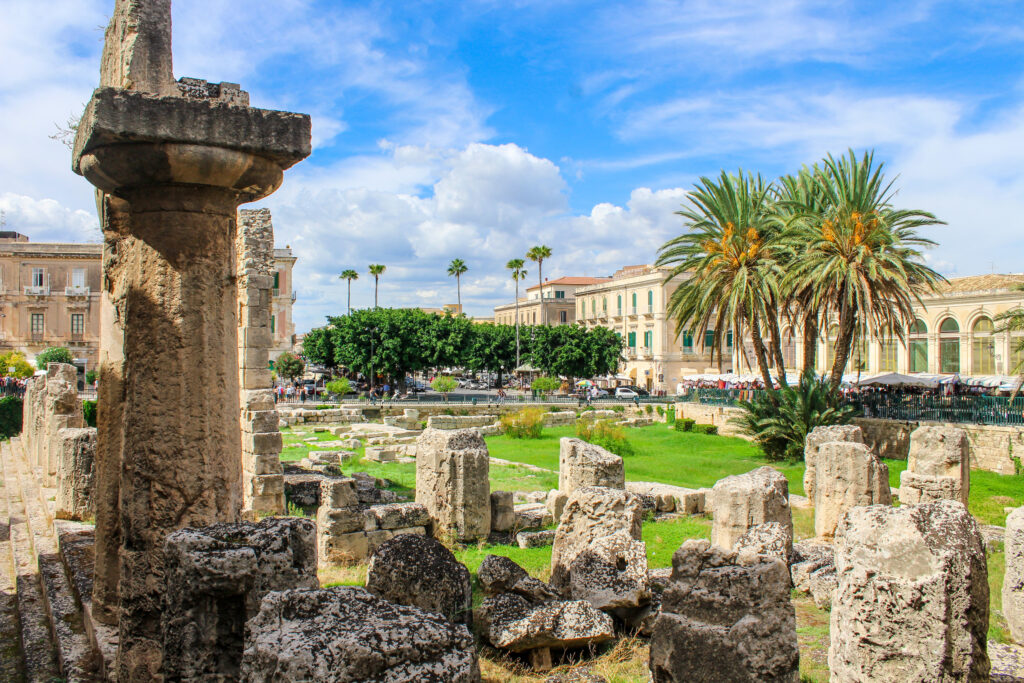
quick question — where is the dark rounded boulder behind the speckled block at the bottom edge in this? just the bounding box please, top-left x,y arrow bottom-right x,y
367,535 -> 473,624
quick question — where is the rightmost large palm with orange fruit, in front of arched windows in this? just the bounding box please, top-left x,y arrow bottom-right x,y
786,150 -> 945,391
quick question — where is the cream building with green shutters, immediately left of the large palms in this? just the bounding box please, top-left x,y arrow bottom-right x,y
575,265 -> 720,393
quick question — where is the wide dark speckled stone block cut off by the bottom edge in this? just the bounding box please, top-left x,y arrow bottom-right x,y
242,587 -> 480,683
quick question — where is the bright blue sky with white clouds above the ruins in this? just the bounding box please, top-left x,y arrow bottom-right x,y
0,0 -> 1024,332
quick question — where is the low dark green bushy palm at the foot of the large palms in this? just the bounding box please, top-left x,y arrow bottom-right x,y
734,371 -> 857,461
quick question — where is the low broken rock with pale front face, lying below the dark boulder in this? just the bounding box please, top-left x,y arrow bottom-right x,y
477,593 -> 614,652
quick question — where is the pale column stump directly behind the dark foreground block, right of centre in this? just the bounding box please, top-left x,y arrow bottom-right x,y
711,467 -> 793,550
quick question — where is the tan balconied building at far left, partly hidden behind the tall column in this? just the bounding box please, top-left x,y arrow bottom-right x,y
0,232 -> 296,370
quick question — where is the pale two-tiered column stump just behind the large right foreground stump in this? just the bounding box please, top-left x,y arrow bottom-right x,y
899,427 -> 971,505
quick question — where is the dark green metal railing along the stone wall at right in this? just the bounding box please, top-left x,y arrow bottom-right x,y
678,389 -> 1024,426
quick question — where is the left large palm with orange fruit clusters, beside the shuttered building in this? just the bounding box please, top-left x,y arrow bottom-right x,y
656,171 -> 785,392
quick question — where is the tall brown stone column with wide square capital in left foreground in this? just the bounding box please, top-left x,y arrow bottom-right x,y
73,0 -> 310,683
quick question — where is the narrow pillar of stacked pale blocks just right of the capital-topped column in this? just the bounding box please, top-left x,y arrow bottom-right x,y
236,209 -> 285,517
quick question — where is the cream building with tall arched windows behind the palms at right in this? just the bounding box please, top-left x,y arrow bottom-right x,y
735,274 -> 1024,376
